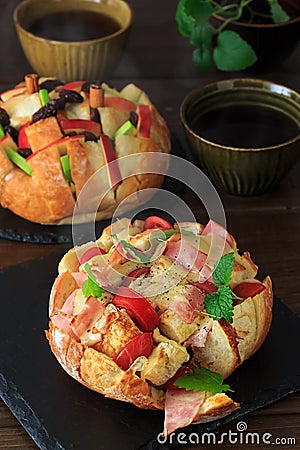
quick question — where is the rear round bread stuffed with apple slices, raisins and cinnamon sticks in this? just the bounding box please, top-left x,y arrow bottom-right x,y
0,78 -> 170,225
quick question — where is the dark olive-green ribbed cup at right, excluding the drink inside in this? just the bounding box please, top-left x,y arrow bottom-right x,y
180,78 -> 300,195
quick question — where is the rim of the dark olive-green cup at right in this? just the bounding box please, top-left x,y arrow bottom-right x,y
180,78 -> 300,152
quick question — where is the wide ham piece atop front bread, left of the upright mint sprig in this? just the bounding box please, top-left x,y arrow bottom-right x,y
164,238 -> 207,271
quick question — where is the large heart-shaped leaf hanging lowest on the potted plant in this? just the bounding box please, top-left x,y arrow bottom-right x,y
213,30 -> 257,71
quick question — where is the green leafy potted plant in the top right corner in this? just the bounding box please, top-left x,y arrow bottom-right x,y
176,0 -> 300,72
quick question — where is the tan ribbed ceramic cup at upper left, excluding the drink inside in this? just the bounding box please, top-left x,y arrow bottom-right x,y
14,0 -> 132,81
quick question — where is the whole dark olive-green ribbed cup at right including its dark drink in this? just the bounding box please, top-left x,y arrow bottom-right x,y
180,78 -> 300,195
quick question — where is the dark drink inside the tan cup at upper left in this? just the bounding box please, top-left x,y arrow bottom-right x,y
28,10 -> 120,42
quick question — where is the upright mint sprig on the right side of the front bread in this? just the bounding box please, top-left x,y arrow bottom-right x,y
204,252 -> 240,323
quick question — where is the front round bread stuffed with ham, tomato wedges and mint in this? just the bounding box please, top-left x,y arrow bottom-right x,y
46,216 -> 273,435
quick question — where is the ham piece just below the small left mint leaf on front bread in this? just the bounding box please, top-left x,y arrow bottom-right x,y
70,297 -> 105,338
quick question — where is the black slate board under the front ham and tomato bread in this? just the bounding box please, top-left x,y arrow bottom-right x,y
0,247 -> 300,450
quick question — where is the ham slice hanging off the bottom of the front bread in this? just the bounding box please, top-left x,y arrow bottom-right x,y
163,389 -> 205,436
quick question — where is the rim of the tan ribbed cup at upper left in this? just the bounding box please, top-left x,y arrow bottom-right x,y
13,0 -> 133,47
